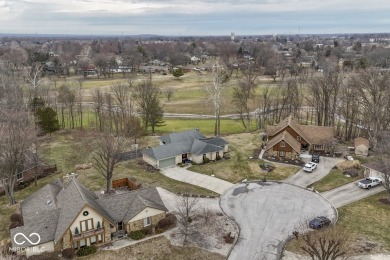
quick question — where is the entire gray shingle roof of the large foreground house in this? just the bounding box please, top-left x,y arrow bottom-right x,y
10,178 -> 168,246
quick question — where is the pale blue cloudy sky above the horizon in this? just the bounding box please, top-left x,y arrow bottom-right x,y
0,0 -> 390,36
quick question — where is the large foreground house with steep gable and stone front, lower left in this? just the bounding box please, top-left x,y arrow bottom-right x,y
10,174 -> 167,257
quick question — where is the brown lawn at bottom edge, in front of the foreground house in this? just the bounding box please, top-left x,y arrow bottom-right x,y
83,236 -> 225,260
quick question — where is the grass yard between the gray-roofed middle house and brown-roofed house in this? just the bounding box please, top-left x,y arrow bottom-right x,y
189,133 -> 299,183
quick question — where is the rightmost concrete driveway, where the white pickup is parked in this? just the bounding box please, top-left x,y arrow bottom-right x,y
321,182 -> 385,208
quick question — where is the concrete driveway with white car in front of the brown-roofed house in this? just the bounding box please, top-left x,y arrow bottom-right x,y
283,156 -> 342,188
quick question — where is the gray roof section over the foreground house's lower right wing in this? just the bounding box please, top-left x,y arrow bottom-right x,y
98,187 -> 168,222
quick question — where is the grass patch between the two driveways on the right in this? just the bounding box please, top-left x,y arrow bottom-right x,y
311,169 -> 362,192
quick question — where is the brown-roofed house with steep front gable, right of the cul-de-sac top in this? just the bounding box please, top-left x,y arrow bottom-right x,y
266,115 -> 335,159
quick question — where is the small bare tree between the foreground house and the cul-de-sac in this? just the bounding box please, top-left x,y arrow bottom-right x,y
176,196 -> 198,245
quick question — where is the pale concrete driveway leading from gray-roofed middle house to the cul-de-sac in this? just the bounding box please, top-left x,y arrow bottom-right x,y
160,166 -> 233,194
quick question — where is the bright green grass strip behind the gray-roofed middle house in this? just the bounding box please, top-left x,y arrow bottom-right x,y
156,118 -> 244,135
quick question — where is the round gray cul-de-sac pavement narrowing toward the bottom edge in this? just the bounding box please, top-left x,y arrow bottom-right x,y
220,182 -> 337,260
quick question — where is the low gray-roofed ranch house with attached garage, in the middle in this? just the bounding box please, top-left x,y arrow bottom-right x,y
143,129 -> 229,169
